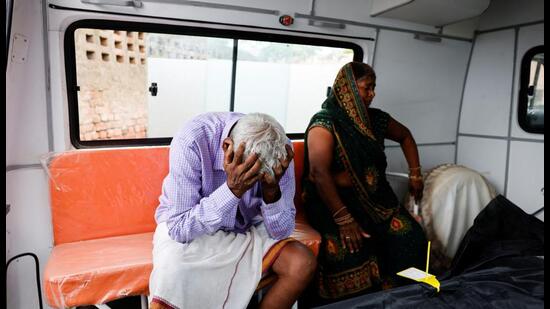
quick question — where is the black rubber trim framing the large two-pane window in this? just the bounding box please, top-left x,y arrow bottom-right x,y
63,19 -> 364,149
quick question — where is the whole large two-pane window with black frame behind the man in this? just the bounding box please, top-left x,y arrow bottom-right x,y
65,23 -> 363,147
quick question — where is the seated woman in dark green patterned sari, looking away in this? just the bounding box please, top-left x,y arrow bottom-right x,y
303,62 -> 427,304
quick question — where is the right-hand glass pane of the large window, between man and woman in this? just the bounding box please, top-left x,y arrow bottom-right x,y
235,40 -> 353,133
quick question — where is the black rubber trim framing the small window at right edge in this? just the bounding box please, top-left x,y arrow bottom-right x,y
517,45 -> 544,134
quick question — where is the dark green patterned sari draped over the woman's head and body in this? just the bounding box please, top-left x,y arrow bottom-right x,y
302,64 -> 427,304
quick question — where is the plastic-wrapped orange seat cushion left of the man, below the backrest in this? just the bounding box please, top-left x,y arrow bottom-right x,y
44,232 -> 153,308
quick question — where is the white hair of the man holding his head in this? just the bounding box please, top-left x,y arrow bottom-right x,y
229,113 -> 288,176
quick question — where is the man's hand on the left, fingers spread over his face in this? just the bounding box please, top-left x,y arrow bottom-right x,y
223,137 -> 262,198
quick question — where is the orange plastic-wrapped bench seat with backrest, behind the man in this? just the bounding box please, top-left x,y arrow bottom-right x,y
44,142 -> 321,308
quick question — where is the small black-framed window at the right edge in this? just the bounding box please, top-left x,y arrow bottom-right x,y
518,46 -> 544,133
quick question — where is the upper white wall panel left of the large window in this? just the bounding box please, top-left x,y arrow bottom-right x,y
6,1 -> 48,165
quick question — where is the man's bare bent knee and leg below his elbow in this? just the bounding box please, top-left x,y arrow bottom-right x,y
260,241 -> 317,309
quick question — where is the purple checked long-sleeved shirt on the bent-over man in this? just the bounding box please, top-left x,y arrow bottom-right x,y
155,112 -> 296,243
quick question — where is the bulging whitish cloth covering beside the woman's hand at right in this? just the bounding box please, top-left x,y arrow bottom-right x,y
421,164 -> 496,258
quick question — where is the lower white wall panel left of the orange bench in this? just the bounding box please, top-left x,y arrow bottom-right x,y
6,169 -> 53,308
